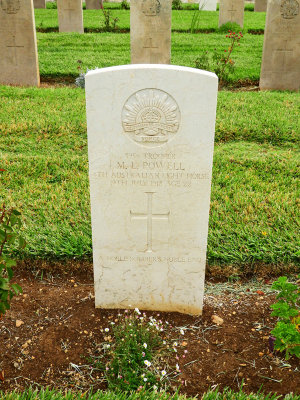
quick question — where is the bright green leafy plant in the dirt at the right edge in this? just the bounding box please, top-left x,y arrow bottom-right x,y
271,275 -> 300,360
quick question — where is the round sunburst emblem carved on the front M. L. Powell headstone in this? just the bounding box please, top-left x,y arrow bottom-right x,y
122,89 -> 180,147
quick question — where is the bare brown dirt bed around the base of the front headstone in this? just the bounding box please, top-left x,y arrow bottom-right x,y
0,268 -> 300,395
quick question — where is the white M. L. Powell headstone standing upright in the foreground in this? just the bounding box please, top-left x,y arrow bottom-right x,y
86,64 -> 218,314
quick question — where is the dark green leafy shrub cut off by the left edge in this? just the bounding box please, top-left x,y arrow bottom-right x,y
0,197 -> 25,319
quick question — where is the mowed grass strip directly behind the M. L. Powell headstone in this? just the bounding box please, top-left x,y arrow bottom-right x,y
0,87 -> 299,267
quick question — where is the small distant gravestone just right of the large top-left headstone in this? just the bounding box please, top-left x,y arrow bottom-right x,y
57,0 -> 84,33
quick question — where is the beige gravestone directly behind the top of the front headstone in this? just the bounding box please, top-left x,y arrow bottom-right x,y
130,0 -> 172,64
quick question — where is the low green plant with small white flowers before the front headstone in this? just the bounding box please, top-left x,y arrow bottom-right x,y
92,308 -> 175,392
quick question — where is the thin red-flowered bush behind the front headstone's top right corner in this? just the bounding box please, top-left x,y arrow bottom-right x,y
195,30 -> 243,84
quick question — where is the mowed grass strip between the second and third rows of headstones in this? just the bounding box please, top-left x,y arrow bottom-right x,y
37,33 -> 263,83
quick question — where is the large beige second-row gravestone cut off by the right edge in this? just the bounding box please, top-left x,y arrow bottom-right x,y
259,0 -> 300,90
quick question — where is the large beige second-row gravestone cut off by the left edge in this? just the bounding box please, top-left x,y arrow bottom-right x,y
0,0 -> 40,86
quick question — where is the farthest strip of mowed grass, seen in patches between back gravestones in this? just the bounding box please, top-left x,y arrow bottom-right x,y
35,9 -> 266,32
